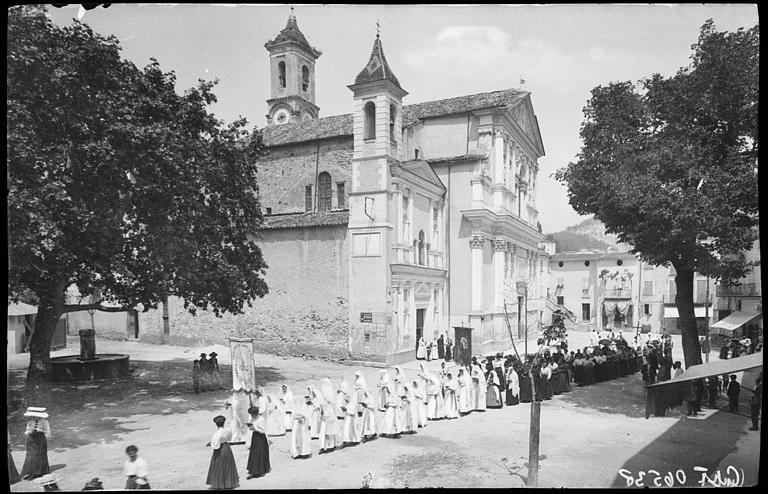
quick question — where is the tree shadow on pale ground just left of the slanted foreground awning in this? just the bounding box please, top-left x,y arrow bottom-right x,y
558,374 -> 645,418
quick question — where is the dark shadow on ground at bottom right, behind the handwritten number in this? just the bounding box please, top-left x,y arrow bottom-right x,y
611,411 -> 747,488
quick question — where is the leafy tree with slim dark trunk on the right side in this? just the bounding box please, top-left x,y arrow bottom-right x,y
556,20 -> 760,366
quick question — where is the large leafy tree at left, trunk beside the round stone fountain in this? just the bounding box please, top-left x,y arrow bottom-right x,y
7,7 -> 267,382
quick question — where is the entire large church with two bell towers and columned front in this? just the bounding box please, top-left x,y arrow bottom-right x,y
136,15 -> 549,363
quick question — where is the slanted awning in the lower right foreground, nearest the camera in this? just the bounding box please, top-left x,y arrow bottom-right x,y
645,352 -> 763,418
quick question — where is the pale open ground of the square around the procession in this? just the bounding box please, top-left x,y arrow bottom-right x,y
8,333 -> 761,491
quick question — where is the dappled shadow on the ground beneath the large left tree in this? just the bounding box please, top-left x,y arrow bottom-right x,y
7,359 -> 284,451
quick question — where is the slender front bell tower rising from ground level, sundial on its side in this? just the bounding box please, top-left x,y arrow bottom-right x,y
347,34 -> 408,356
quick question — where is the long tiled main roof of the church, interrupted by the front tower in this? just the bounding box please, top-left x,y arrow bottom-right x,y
262,89 -> 529,147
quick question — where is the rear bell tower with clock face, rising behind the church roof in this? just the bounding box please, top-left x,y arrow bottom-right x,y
264,7 -> 321,125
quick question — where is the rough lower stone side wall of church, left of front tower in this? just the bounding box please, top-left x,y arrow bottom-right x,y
139,225 -> 349,358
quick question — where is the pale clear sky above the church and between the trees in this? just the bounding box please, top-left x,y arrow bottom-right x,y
49,4 -> 758,233
